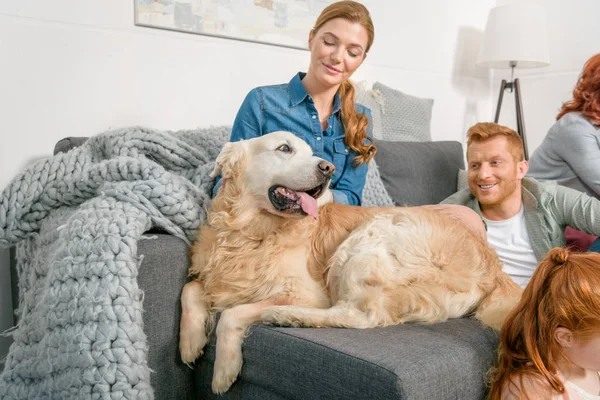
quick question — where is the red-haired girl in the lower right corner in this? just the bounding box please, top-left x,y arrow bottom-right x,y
490,248 -> 600,400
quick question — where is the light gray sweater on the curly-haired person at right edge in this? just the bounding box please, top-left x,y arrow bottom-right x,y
527,112 -> 600,198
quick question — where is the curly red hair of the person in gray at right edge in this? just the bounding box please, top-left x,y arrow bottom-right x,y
556,53 -> 600,126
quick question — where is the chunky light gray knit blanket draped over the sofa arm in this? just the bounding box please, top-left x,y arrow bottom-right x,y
0,127 -> 231,399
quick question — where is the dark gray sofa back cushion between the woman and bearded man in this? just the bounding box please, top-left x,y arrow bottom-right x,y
375,140 -> 464,206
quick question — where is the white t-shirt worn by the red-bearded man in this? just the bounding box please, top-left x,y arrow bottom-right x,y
483,204 -> 538,288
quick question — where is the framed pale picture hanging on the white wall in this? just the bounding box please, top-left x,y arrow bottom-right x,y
134,0 -> 335,49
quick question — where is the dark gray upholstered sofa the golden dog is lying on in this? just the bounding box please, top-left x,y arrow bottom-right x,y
8,138 -> 498,400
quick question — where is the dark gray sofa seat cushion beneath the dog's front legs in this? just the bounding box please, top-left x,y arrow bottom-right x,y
196,318 -> 498,400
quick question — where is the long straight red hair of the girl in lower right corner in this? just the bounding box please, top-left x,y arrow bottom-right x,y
490,248 -> 600,400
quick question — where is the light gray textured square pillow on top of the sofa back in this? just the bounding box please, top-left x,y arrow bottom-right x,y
373,82 -> 433,142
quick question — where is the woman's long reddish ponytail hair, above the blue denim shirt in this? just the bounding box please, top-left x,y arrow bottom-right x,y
312,0 -> 377,165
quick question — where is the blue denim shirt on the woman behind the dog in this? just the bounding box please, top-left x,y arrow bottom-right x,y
213,73 -> 372,205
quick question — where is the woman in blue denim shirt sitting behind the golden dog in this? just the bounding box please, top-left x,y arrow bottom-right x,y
214,0 -> 376,205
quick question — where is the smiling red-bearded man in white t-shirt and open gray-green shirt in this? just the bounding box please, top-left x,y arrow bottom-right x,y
442,122 -> 600,287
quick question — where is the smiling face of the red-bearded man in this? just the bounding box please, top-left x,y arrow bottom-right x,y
467,136 -> 528,208
